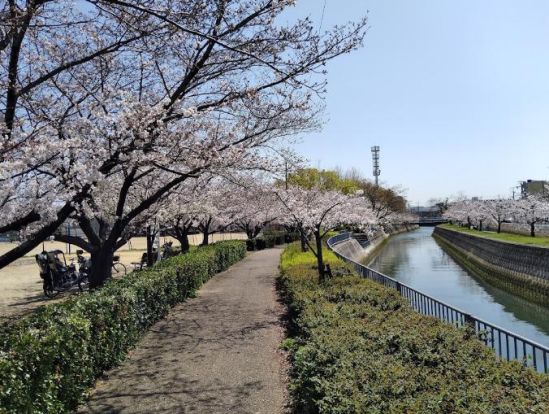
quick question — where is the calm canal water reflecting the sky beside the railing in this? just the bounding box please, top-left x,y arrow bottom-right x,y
368,227 -> 549,346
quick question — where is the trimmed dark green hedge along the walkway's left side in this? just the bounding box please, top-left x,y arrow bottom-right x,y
0,241 -> 246,413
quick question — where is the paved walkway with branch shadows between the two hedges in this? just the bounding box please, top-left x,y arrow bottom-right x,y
79,249 -> 287,414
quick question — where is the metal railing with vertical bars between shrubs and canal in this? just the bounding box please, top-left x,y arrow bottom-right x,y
327,233 -> 549,373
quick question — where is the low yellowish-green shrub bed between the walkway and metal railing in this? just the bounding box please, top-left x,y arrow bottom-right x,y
279,241 -> 549,414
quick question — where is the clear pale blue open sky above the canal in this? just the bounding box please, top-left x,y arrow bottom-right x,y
284,0 -> 549,204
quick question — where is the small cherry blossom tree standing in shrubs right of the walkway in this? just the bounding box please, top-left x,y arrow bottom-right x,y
277,187 -> 376,282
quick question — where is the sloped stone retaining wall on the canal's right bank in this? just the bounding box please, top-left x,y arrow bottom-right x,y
433,227 -> 549,305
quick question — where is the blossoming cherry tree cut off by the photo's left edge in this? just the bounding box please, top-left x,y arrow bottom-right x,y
0,0 -> 161,267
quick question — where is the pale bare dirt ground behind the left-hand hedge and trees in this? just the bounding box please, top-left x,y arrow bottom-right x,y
0,233 -> 246,322
